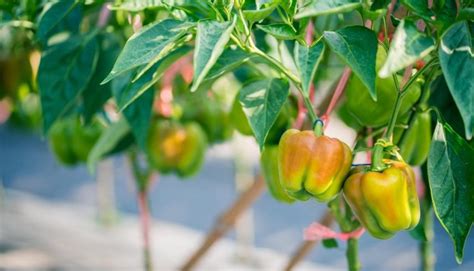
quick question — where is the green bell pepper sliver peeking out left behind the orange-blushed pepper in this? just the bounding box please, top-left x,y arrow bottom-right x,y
260,145 -> 295,203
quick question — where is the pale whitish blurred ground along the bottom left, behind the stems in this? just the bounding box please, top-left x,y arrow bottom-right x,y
0,191 -> 337,270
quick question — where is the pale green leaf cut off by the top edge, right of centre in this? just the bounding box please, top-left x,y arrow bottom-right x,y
295,0 -> 361,19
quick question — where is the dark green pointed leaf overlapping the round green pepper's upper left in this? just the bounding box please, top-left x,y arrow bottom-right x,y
324,26 -> 377,101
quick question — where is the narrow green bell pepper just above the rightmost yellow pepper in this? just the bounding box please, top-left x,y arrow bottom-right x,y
393,111 -> 431,166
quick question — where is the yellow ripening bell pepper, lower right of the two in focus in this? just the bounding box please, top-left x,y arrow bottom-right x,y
343,160 -> 420,239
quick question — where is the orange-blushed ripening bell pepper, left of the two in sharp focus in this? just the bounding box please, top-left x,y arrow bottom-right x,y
278,129 -> 352,202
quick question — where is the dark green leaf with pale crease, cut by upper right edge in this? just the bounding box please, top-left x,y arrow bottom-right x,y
438,22 -> 474,139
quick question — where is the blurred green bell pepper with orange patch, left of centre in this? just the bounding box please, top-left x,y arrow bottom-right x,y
147,120 -> 207,177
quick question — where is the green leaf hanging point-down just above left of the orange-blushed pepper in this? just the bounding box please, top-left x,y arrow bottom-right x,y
239,78 -> 289,148
